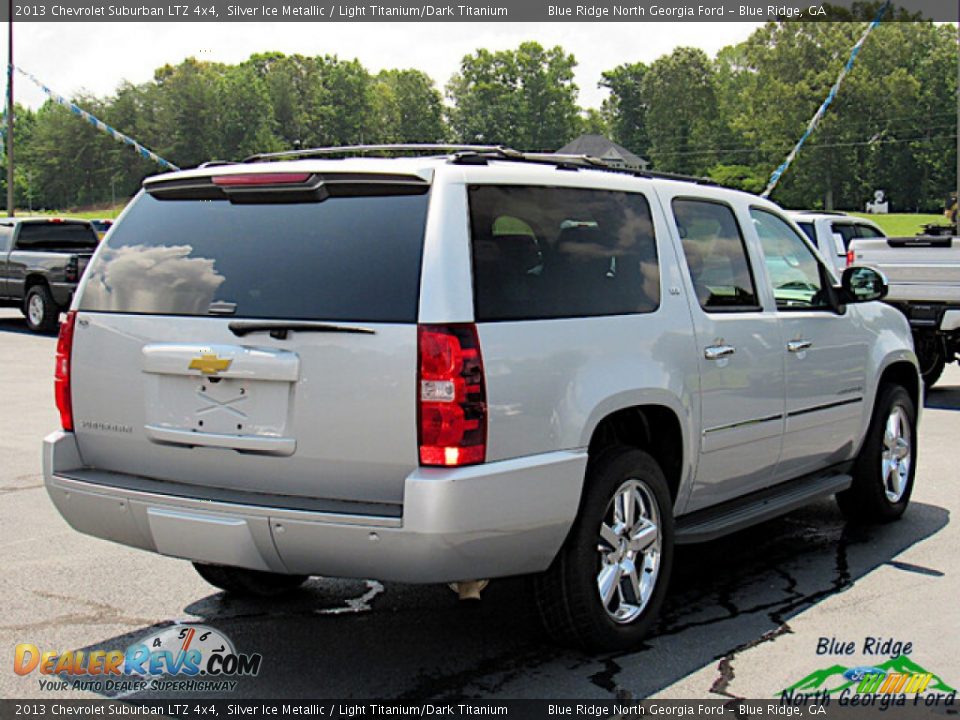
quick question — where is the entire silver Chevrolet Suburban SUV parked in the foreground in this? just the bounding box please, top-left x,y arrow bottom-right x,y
44,148 -> 920,649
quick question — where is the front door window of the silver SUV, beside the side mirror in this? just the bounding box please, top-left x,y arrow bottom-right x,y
750,208 -> 829,310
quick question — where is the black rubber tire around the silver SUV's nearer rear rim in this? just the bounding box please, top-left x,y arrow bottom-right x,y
533,447 -> 673,651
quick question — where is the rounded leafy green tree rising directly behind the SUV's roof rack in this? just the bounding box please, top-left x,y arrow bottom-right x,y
447,42 -> 580,151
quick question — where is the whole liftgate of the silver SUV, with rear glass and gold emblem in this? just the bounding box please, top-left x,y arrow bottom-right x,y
73,174 -> 429,503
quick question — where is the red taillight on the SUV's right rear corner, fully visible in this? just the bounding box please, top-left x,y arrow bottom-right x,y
418,324 -> 487,467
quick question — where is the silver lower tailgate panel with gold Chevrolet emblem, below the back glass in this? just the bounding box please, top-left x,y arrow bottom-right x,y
72,312 -> 417,503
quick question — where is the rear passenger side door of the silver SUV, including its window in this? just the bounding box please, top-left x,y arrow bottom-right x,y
670,197 -> 784,510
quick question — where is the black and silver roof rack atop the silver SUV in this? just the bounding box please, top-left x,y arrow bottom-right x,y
242,143 -> 719,185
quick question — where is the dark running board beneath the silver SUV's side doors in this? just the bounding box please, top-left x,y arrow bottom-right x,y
676,467 -> 853,545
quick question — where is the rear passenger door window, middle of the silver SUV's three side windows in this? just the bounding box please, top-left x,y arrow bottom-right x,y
673,198 -> 759,311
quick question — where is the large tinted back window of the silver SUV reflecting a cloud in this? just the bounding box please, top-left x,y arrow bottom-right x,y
79,188 -> 428,323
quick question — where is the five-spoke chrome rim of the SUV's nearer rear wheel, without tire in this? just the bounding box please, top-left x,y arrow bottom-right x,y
597,480 -> 663,624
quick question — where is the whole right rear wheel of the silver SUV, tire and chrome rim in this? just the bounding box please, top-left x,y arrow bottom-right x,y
534,448 -> 673,651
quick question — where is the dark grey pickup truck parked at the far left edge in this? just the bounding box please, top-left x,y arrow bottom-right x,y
0,217 -> 99,332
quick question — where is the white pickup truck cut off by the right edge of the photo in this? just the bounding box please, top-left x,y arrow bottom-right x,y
848,235 -> 960,387
